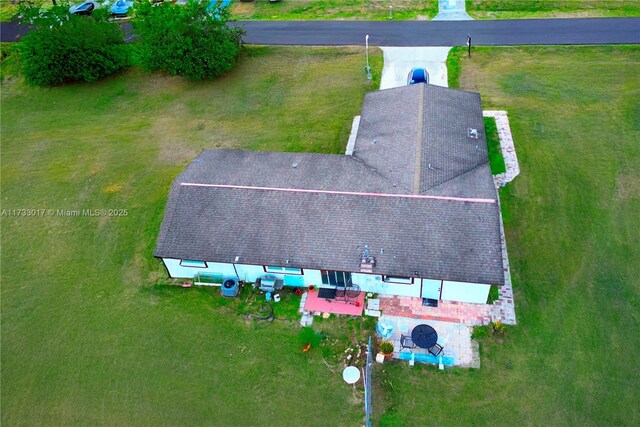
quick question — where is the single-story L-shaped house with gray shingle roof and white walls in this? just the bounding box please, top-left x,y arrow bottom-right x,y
155,84 -> 504,303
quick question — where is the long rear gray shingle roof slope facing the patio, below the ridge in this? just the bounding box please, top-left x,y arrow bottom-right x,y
156,185 -> 502,283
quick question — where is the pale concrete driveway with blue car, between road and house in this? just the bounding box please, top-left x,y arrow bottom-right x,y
380,46 -> 451,89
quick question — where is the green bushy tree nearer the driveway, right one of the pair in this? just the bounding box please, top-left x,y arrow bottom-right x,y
133,0 -> 244,79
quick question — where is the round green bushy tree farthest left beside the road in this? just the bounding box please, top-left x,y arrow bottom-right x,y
19,5 -> 130,86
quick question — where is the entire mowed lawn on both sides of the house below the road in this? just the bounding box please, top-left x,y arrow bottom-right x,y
0,42 -> 640,426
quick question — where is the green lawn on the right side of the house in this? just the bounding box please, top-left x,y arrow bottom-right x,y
374,47 -> 640,426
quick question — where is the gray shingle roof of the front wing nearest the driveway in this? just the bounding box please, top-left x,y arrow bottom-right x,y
353,84 -> 495,197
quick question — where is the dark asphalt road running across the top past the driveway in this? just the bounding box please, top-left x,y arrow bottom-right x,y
0,18 -> 640,46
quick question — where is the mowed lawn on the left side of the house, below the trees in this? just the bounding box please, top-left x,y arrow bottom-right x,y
0,48 -> 382,426
